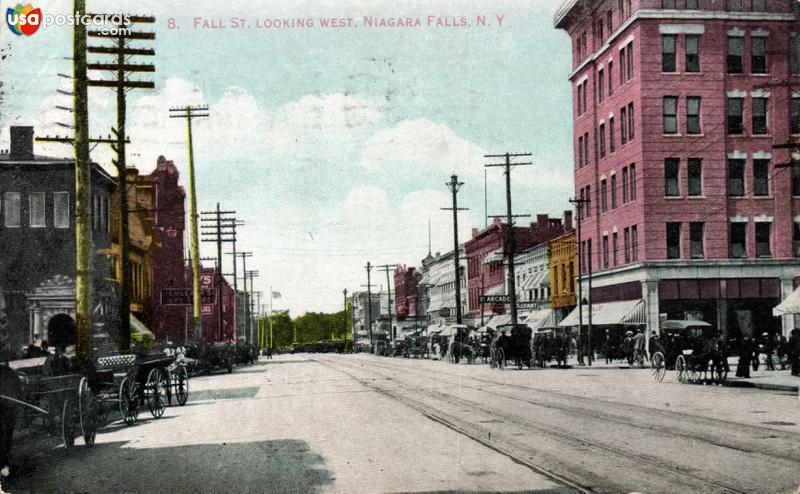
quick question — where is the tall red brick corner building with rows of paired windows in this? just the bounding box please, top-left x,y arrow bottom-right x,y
554,0 -> 800,337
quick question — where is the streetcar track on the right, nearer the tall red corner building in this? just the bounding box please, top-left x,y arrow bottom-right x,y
354,356 -> 800,465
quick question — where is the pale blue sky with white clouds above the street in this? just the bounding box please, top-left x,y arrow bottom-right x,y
0,0 -> 572,313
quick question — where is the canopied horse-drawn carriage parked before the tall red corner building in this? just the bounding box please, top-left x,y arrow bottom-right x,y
650,320 -> 728,383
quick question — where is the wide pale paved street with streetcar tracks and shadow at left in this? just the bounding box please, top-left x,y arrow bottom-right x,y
12,354 -> 800,492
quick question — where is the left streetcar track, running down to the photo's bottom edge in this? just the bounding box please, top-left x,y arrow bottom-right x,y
317,361 -> 747,493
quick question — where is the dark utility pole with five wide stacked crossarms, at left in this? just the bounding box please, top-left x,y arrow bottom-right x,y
87,16 -> 156,353
